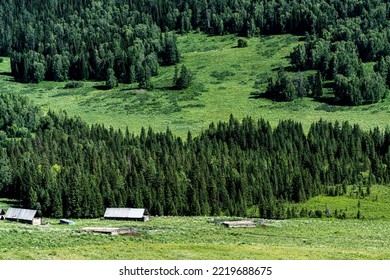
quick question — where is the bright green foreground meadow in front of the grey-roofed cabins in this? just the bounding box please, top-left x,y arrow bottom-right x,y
0,186 -> 390,260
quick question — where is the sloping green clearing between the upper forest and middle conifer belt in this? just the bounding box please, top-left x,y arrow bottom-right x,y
0,34 -> 390,136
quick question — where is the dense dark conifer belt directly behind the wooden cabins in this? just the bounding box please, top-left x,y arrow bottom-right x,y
0,94 -> 390,218
